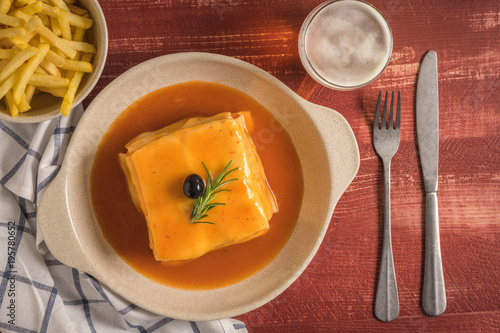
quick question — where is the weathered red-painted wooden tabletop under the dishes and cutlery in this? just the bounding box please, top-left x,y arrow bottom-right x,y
85,0 -> 500,332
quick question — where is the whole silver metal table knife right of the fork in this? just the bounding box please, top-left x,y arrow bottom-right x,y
416,51 -> 446,316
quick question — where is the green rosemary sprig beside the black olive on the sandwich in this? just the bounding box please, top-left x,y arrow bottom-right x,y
191,161 -> 238,224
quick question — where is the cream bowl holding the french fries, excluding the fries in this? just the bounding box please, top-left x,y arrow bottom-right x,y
0,0 -> 108,123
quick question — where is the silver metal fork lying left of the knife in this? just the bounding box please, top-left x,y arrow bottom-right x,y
373,90 -> 401,321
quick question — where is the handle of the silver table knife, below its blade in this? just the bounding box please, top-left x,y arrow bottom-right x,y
422,192 -> 446,316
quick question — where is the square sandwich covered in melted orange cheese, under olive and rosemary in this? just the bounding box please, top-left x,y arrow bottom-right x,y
120,113 -> 278,261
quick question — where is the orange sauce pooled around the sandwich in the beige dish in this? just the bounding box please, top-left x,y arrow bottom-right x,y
91,81 -> 303,290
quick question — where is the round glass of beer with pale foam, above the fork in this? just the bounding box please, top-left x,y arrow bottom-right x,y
299,0 -> 392,90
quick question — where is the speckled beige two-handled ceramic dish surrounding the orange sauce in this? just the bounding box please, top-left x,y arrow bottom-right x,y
39,53 -> 359,320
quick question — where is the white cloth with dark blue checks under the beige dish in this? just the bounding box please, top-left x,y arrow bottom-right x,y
0,105 -> 247,333
